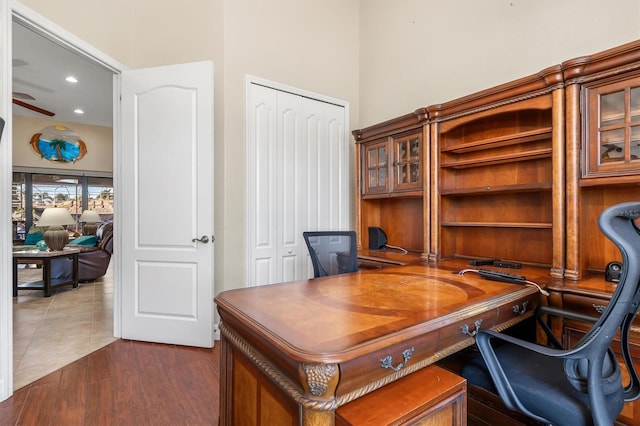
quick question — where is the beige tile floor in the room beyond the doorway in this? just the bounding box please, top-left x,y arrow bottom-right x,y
13,266 -> 116,390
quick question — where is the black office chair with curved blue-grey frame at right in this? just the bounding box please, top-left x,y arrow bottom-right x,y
462,202 -> 640,425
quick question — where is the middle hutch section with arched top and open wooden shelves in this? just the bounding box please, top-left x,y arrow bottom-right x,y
427,66 -> 564,277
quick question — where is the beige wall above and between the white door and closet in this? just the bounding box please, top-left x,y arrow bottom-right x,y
22,0 -> 359,292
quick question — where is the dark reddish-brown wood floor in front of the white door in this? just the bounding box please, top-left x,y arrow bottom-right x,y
0,340 -> 220,426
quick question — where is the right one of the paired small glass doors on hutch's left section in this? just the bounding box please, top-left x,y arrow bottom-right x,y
393,135 -> 422,190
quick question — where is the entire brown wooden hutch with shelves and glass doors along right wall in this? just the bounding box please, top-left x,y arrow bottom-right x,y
353,41 -> 640,424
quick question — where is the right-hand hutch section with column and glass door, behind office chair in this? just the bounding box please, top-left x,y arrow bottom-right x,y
562,41 -> 640,280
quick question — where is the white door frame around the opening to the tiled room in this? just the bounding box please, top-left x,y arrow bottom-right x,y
0,0 -> 127,401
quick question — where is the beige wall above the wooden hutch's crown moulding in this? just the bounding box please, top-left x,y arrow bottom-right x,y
354,0 -> 640,127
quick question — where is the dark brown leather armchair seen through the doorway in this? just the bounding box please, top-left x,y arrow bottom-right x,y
51,223 -> 113,282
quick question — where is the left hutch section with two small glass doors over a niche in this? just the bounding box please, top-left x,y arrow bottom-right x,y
352,109 -> 430,257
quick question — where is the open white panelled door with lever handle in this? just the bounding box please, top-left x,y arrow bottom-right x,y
118,61 -> 214,347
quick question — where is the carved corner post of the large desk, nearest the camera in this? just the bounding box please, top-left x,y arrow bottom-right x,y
298,364 -> 339,426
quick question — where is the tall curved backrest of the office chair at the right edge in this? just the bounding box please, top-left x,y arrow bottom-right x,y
565,202 -> 640,411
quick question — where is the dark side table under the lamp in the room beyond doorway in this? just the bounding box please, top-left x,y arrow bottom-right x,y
13,247 -> 80,297
